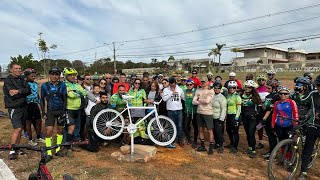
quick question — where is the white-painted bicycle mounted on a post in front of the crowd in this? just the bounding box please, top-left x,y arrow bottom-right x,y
93,95 -> 177,148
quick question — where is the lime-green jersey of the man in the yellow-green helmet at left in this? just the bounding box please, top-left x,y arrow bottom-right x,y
65,81 -> 87,110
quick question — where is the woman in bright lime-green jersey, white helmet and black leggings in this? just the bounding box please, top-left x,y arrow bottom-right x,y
226,81 -> 241,154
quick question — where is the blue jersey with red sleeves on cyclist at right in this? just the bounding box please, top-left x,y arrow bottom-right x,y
271,99 -> 299,127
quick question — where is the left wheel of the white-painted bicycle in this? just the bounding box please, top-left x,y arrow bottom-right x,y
93,109 -> 124,140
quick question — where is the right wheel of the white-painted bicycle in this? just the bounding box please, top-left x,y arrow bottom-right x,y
147,115 -> 177,146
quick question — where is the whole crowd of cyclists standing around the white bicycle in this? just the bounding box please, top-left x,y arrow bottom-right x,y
3,64 -> 320,179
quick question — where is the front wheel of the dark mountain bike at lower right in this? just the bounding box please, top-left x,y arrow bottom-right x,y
268,139 -> 302,180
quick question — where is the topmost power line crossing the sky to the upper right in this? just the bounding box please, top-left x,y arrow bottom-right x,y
117,4 -> 320,43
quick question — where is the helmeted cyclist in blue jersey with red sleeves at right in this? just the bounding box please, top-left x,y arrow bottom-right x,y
271,86 -> 299,142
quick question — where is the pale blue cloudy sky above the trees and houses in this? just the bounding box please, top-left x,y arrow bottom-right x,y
0,0 -> 320,65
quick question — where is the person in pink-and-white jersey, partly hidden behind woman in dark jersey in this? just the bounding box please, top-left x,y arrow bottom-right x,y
257,75 -> 269,149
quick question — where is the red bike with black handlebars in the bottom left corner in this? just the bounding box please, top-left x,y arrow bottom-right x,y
0,141 -> 88,180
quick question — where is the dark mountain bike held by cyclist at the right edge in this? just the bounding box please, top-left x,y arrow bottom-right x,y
268,118 -> 320,180
